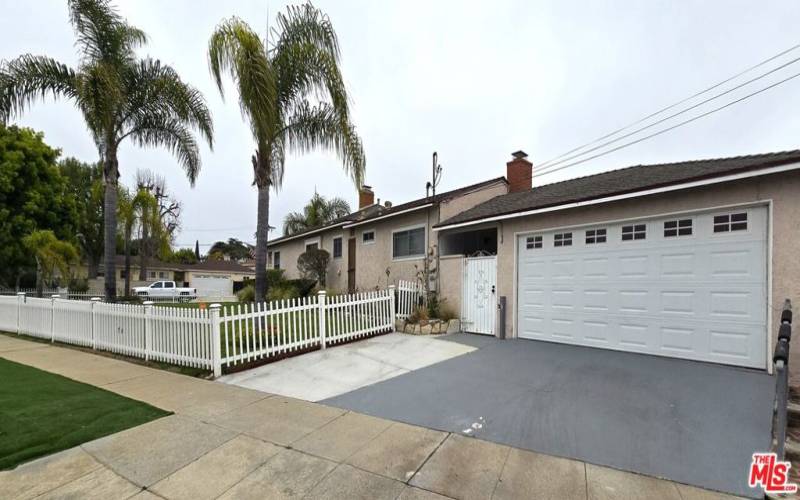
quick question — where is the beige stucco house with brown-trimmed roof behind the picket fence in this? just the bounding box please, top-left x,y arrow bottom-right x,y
267,177 -> 508,296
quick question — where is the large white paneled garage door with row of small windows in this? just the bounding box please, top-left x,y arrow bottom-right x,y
516,207 -> 767,368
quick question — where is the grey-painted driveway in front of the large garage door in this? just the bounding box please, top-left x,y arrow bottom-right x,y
324,334 -> 774,497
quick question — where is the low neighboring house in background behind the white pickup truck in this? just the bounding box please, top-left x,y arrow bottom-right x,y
82,255 -> 255,298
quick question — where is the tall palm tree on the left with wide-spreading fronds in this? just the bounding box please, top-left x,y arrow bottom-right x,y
0,0 -> 213,300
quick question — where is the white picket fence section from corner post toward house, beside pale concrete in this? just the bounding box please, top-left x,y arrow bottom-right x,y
220,286 -> 395,367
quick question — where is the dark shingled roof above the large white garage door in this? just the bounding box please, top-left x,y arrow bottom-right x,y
434,150 -> 800,228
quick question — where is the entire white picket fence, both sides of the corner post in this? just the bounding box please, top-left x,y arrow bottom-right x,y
0,286 -> 395,376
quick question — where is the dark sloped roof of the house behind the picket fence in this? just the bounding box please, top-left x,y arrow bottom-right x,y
267,176 -> 507,246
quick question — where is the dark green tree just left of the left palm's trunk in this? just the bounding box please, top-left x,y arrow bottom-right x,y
58,158 -> 103,279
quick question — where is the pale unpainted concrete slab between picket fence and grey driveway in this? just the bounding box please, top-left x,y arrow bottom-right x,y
219,333 -> 475,401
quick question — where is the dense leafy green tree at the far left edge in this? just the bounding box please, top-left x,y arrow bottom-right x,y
0,124 -> 77,287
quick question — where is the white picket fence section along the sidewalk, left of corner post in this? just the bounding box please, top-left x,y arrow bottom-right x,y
0,294 -> 220,375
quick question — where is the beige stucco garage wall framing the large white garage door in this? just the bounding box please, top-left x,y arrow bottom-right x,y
484,172 -> 800,381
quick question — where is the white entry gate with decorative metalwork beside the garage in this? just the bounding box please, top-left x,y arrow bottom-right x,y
461,255 -> 497,335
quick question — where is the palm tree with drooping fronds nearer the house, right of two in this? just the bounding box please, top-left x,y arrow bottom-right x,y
208,4 -> 366,301
